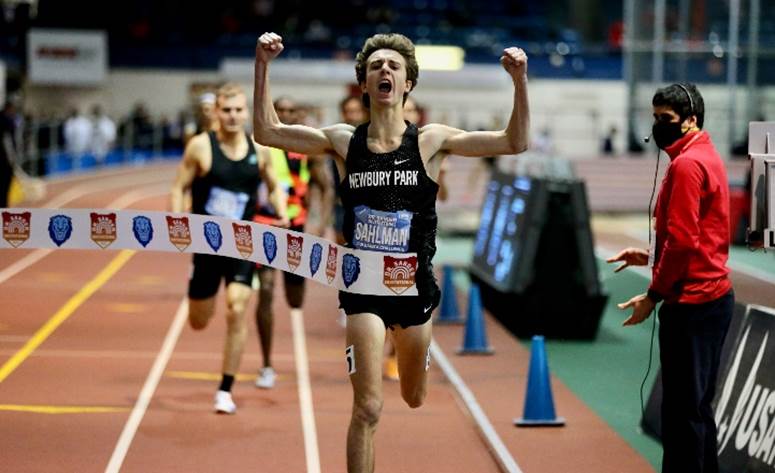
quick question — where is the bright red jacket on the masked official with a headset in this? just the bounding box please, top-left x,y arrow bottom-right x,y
649,131 -> 732,304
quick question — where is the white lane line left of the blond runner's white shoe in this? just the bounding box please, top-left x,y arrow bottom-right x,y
105,297 -> 188,473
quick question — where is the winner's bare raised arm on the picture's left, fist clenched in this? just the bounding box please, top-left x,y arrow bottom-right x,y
253,33 -> 352,155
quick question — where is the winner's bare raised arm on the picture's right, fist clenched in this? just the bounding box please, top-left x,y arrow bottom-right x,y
422,48 -> 530,157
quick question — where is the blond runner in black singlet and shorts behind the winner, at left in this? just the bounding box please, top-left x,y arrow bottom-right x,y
171,84 -> 287,414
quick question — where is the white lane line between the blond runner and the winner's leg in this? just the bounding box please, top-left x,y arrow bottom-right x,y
291,309 -> 320,473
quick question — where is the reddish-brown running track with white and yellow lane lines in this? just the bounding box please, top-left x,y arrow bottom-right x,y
0,165 -> 653,473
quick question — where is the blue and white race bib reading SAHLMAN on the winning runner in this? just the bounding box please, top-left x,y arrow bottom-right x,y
352,205 -> 413,253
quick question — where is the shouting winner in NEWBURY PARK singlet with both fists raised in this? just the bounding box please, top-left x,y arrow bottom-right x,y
254,33 -> 529,473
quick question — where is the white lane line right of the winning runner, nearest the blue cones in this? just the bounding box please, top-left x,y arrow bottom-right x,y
431,340 -> 522,473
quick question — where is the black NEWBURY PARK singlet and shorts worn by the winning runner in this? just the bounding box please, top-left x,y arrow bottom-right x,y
339,122 -> 440,328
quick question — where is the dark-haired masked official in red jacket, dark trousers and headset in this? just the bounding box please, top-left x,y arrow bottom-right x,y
608,84 -> 734,473
